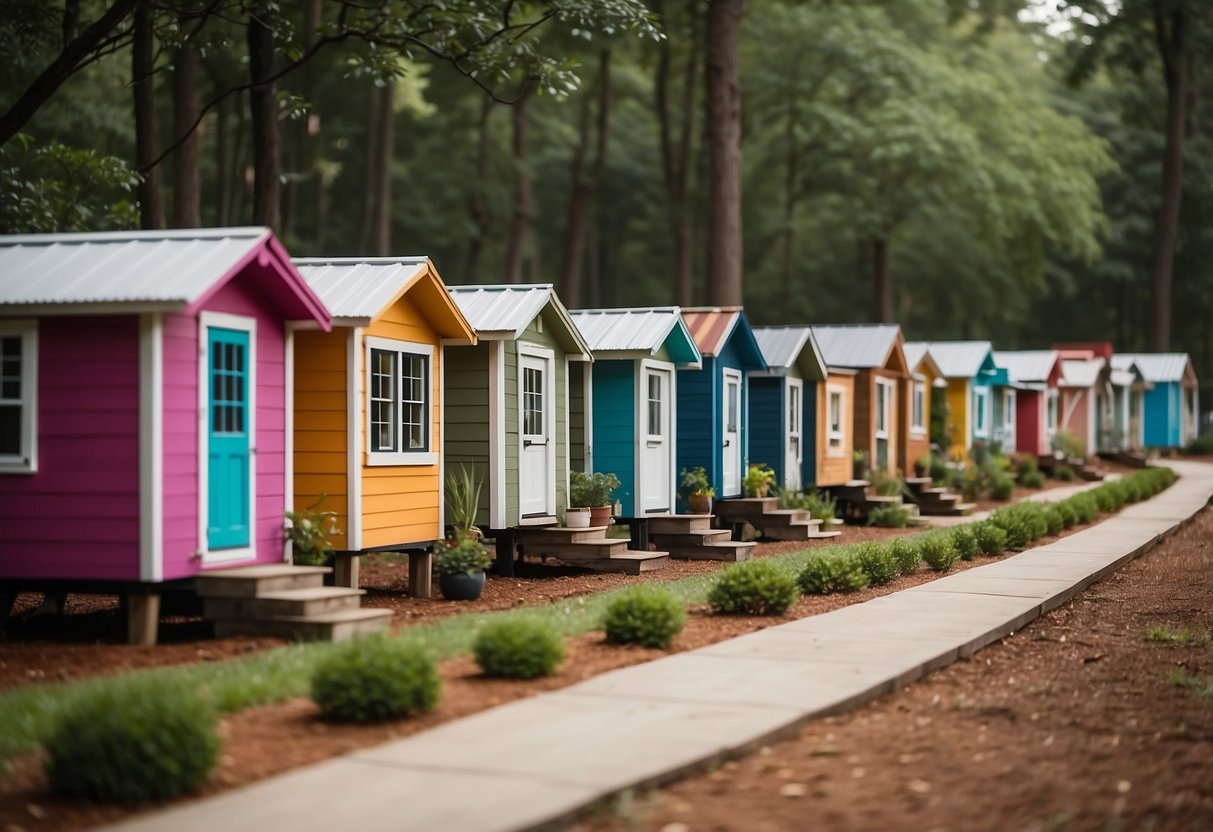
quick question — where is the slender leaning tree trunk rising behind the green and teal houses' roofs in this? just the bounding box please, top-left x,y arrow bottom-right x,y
558,50 -> 611,308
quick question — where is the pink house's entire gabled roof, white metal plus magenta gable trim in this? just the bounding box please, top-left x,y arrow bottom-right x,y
0,227 -> 329,327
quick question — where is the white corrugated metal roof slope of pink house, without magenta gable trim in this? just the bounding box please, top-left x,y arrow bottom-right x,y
0,228 -> 269,307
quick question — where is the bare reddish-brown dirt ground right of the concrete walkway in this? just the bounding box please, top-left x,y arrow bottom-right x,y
577,504 -> 1213,832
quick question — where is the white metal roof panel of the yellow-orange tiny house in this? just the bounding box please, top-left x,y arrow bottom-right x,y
291,257 -> 427,319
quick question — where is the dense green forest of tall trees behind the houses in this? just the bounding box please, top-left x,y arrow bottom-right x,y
0,0 -> 1213,412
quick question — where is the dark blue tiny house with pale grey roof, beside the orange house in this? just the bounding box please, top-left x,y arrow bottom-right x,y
750,326 -> 826,491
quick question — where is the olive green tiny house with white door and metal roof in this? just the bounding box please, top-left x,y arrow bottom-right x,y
443,285 -> 592,530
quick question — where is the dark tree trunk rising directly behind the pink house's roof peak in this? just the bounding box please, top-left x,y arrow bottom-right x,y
247,7 -> 281,230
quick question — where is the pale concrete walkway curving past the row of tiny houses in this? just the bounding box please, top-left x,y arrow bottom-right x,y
110,462 -> 1213,832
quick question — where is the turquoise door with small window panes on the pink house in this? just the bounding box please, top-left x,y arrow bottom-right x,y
206,327 -> 251,549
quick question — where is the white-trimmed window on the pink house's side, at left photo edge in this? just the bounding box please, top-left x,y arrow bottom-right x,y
0,321 -> 38,473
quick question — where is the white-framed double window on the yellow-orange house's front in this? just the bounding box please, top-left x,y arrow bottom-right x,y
366,337 -> 438,466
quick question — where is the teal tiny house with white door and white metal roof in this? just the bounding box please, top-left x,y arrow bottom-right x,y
571,307 -> 702,517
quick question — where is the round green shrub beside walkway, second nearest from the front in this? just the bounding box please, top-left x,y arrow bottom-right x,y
312,636 -> 442,722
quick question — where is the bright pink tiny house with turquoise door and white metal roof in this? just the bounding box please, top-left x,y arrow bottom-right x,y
0,228 -> 330,640
